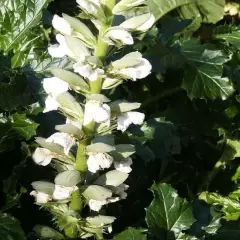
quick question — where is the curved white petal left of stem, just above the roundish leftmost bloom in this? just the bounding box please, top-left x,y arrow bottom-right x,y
46,132 -> 75,155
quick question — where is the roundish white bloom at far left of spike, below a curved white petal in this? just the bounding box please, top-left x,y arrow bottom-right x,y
32,148 -> 56,166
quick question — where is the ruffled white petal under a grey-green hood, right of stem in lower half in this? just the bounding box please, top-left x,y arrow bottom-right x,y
87,153 -> 113,173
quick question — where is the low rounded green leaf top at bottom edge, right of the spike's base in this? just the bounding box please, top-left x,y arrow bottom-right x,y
113,227 -> 147,240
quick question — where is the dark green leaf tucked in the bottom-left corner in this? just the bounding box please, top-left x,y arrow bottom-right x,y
0,213 -> 27,240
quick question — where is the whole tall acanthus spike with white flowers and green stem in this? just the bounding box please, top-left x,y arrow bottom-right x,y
31,0 -> 155,239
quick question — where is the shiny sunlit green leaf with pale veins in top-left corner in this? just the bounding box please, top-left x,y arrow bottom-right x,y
0,0 -> 51,67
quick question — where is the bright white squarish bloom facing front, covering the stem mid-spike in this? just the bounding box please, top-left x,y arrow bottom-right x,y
83,101 -> 111,126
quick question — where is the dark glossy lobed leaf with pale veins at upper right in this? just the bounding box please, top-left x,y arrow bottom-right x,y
180,39 -> 234,100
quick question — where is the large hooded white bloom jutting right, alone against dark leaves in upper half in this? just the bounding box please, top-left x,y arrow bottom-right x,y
112,52 -> 152,81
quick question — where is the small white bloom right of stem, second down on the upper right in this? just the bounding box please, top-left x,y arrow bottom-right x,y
103,27 -> 134,46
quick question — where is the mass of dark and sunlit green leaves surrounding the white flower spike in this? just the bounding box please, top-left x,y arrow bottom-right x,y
0,0 -> 240,240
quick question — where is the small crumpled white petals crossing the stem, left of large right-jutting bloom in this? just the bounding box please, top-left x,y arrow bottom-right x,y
73,61 -> 104,81
